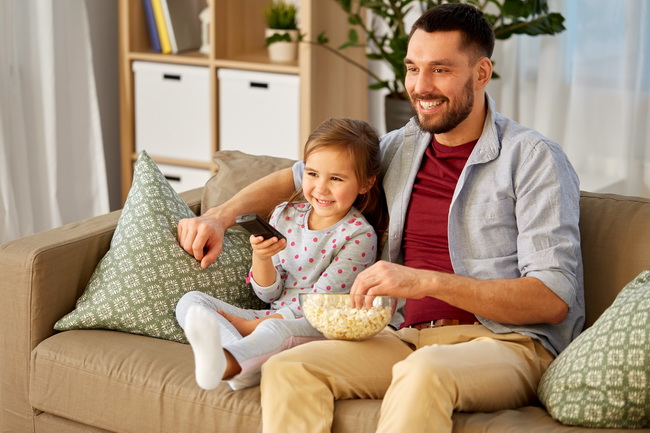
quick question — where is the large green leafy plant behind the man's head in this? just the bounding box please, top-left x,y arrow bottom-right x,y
307,0 -> 564,99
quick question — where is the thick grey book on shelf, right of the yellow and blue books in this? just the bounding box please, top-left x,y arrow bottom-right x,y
162,0 -> 204,53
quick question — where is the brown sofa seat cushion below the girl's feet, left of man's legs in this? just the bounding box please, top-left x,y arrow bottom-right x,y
29,330 -> 262,433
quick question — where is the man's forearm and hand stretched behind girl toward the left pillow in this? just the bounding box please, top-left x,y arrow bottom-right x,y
178,168 -> 295,269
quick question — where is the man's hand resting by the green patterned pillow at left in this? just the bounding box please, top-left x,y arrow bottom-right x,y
177,216 -> 226,269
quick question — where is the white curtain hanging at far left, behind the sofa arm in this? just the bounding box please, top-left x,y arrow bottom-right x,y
0,0 -> 109,244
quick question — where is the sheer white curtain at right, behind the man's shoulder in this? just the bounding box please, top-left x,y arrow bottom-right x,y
488,0 -> 650,197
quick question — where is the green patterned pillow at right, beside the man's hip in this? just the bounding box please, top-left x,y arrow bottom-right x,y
539,271 -> 650,428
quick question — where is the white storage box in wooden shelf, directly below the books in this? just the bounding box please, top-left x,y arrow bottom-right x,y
133,61 -> 212,162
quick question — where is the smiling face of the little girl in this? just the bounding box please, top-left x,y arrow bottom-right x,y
302,148 -> 372,230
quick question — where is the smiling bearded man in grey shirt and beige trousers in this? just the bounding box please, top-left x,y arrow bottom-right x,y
180,4 -> 584,432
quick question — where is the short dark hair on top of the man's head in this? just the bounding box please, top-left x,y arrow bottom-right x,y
409,3 -> 494,59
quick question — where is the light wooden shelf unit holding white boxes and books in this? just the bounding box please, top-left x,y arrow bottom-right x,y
118,0 -> 368,200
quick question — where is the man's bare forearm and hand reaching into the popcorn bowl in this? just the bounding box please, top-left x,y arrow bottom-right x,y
351,261 -> 568,325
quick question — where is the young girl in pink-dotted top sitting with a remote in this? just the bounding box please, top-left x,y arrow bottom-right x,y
176,119 -> 381,390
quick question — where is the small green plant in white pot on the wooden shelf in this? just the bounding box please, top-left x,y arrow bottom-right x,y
264,0 -> 300,62
